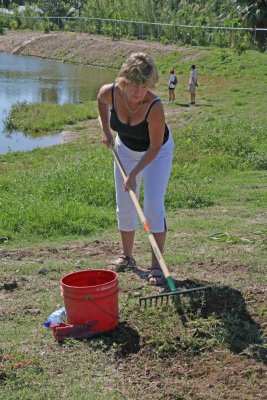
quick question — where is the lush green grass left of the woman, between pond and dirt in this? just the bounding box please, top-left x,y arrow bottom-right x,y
0,144 -> 115,238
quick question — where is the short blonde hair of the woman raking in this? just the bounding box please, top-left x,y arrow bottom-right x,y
116,53 -> 159,88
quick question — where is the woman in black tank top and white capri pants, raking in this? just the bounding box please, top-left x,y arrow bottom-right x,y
98,53 -> 173,285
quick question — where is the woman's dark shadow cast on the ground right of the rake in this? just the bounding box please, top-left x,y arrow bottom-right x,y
175,279 -> 267,364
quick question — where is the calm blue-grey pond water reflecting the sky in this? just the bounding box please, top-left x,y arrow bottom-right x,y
0,53 -> 117,154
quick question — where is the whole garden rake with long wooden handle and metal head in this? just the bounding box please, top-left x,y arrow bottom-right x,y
112,147 -> 210,308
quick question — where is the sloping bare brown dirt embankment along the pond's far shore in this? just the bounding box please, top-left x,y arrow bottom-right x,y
0,31 -> 200,68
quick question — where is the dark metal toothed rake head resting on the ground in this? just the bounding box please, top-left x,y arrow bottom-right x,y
139,286 -> 211,308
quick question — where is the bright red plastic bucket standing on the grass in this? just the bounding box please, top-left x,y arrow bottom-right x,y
61,269 -> 119,332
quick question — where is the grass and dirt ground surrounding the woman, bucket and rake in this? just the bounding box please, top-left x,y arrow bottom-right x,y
0,42 -> 267,400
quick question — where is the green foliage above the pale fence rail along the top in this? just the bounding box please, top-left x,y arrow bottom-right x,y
0,0 -> 267,48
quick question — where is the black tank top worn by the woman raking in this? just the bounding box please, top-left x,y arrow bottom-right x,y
110,83 -> 169,151
